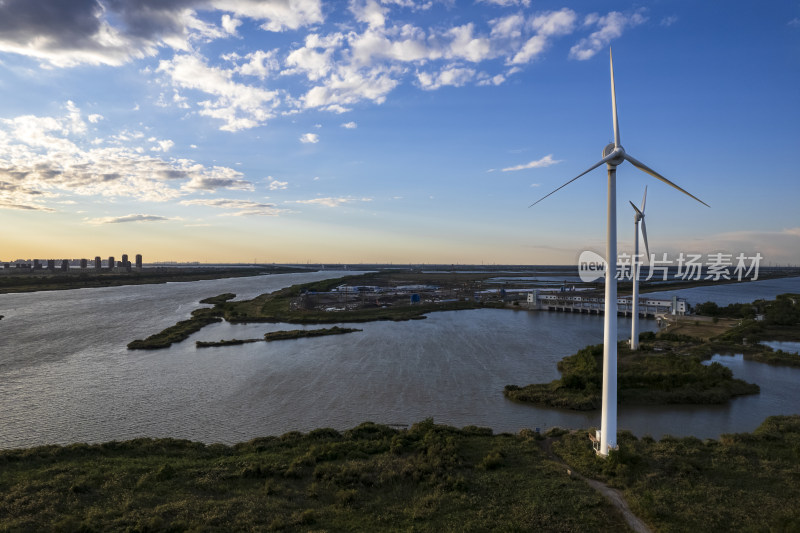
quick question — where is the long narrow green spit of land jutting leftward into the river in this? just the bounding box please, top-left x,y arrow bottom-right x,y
128,273 -> 490,350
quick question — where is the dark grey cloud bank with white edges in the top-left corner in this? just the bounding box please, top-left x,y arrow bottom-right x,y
0,0 -> 324,67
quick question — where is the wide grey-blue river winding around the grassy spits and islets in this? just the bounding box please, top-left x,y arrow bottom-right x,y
0,271 -> 800,448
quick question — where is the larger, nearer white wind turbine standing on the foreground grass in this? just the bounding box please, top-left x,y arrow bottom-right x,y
530,48 -> 710,457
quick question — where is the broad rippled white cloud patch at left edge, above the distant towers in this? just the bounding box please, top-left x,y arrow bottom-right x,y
0,104 -> 252,210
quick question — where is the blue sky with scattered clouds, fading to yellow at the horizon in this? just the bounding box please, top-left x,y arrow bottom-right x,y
0,0 -> 800,264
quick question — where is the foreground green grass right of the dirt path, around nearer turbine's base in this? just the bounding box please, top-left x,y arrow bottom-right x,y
553,415 -> 800,532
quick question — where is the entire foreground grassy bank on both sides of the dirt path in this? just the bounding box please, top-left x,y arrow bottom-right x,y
0,416 -> 800,531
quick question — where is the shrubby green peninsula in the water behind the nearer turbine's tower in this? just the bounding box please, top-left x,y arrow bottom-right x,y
504,294 -> 800,410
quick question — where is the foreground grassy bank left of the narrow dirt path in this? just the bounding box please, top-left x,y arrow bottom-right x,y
0,421 -> 625,531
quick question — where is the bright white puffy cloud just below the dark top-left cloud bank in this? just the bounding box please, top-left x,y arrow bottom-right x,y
157,54 -> 279,131
